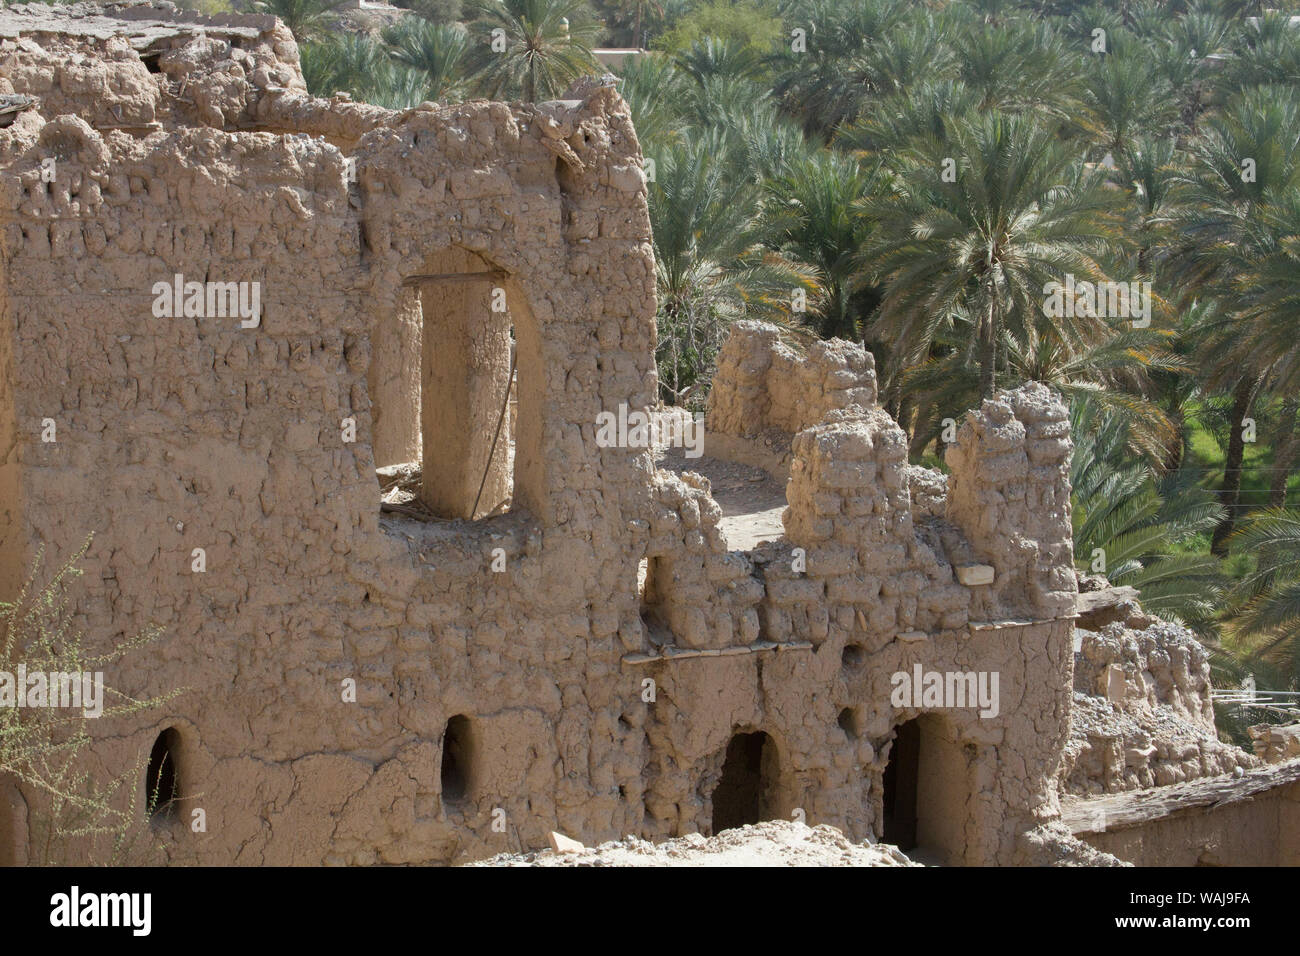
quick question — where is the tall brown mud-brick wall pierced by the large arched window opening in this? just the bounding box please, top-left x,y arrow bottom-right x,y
0,1 -> 654,864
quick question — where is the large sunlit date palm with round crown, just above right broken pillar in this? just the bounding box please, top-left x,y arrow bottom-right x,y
861,112 -> 1122,398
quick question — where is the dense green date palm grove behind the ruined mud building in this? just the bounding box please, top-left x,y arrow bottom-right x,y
255,0 -> 1300,739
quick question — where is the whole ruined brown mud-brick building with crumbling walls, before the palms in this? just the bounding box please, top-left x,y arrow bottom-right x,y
0,5 -> 1294,864
